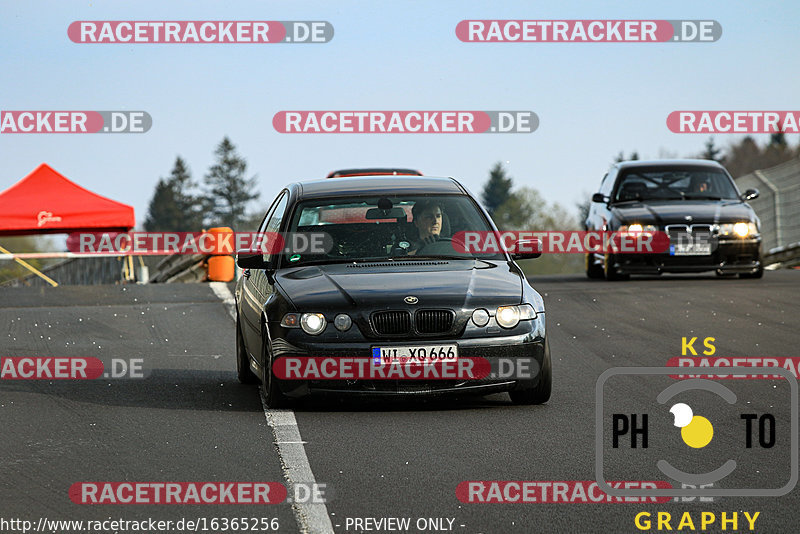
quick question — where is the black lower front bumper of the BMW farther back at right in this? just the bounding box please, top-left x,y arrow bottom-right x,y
611,237 -> 762,274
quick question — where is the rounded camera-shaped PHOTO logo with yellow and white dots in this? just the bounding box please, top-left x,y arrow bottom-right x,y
595,367 -> 798,497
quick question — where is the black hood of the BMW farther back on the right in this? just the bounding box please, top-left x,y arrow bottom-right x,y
611,200 -> 755,227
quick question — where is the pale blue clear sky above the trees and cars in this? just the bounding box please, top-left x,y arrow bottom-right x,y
0,0 -> 800,226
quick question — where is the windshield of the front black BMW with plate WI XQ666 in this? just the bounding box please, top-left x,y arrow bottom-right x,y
281,195 -> 505,266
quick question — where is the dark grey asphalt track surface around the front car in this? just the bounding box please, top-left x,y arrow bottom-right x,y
0,271 -> 800,533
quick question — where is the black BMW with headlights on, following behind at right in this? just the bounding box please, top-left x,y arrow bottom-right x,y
585,160 -> 764,280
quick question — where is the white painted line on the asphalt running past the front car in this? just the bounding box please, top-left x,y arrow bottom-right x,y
208,282 -> 333,534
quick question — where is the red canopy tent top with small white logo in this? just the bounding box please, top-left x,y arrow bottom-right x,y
0,163 -> 135,235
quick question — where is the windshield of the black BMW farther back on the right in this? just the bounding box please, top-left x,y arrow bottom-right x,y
612,167 -> 737,202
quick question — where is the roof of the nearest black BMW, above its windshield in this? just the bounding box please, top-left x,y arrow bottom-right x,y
292,175 -> 467,200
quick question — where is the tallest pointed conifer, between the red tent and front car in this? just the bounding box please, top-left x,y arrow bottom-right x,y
204,136 -> 259,229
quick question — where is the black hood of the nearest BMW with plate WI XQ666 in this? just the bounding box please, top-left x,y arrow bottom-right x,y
276,260 -> 522,313
